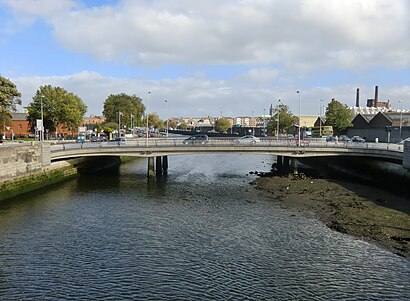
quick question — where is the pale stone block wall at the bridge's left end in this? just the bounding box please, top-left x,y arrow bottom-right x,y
0,142 -> 51,183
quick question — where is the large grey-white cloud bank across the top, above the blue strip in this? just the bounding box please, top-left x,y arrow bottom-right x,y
3,0 -> 410,70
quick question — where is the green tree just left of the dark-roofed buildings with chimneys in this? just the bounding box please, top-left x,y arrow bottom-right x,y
326,98 -> 353,133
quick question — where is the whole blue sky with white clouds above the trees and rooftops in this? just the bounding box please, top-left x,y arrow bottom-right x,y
0,0 -> 410,119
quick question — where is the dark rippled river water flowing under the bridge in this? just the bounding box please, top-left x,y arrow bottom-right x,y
0,155 -> 410,300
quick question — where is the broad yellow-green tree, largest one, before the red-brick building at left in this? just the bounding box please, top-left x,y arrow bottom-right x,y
27,85 -> 87,132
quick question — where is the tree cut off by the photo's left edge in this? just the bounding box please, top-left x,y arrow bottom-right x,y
0,76 -> 21,125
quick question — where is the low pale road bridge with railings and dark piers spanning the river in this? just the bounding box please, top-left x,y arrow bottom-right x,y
50,138 -> 410,175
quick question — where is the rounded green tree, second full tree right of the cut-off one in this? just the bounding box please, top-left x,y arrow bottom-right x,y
103,93 -> 146,127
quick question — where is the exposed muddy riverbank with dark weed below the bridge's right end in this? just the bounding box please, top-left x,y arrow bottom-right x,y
252,176 -> 410,258
